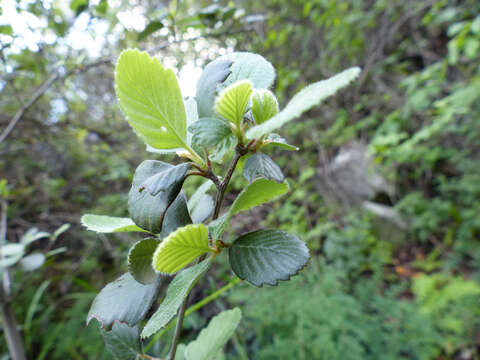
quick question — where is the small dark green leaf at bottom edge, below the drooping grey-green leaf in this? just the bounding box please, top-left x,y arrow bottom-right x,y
102,322 -> 142,360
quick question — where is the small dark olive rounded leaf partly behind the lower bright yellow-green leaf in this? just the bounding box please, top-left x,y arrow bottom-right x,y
128,238 -> 160,284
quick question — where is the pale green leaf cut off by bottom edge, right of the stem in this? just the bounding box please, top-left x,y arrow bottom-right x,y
185,308 -> 242,360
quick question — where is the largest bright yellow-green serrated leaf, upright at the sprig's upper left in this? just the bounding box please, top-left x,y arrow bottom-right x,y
115,50 -> 188,149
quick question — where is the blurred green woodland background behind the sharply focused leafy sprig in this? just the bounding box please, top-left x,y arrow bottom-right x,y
0,0 -> 480,359
